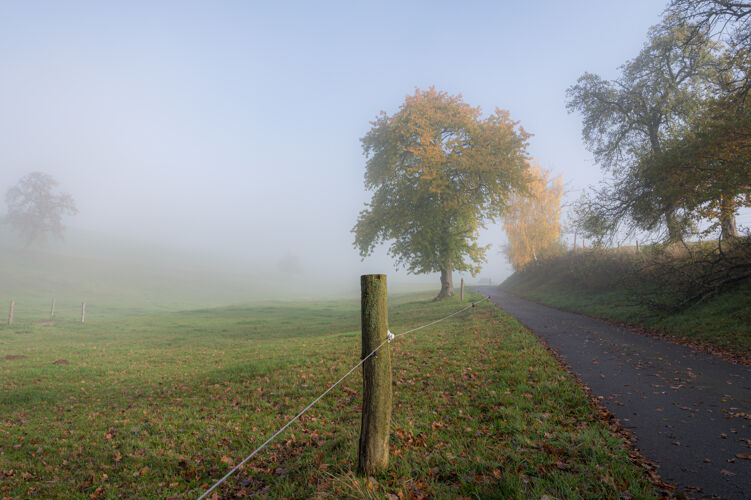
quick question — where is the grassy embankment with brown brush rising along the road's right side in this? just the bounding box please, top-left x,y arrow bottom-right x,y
501,248 -> 751,356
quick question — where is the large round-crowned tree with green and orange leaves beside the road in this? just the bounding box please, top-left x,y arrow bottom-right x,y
353,87 -> 528,299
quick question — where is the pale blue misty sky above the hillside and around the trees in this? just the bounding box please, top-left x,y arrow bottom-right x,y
0,0 -> 688,282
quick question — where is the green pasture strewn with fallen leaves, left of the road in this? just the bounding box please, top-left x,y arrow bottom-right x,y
0,294 -> 655,498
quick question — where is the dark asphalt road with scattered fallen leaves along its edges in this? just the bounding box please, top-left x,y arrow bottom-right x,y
477,287 -> 751,499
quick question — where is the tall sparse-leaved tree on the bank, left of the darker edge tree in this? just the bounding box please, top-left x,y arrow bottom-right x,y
567,19 -> 718,241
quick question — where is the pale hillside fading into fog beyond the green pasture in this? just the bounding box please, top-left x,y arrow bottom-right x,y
0,224 -> 452,317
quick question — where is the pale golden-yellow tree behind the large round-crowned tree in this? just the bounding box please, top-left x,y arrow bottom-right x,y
503,163 -> 563,271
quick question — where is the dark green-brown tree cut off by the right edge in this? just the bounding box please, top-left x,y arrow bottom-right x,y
642,0 -> 751,239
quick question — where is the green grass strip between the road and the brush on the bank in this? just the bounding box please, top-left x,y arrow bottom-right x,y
501,253 -> 751,356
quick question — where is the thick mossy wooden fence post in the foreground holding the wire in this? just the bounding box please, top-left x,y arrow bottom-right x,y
357,274 -> 391,476
